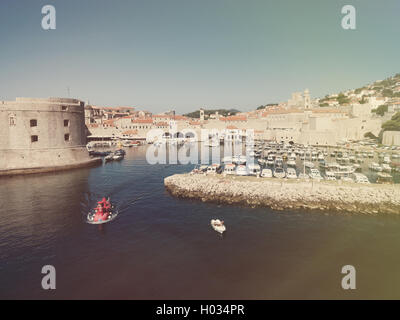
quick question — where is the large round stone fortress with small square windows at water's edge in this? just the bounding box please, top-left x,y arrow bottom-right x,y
0,98 -> 101,176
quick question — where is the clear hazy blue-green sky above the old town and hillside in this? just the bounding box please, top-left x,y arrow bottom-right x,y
0,0 -> 400,113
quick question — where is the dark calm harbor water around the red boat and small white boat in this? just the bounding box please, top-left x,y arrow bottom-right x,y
0,146 -> 400,299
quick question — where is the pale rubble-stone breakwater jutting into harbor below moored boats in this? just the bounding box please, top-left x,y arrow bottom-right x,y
164,174 -> 400,214
